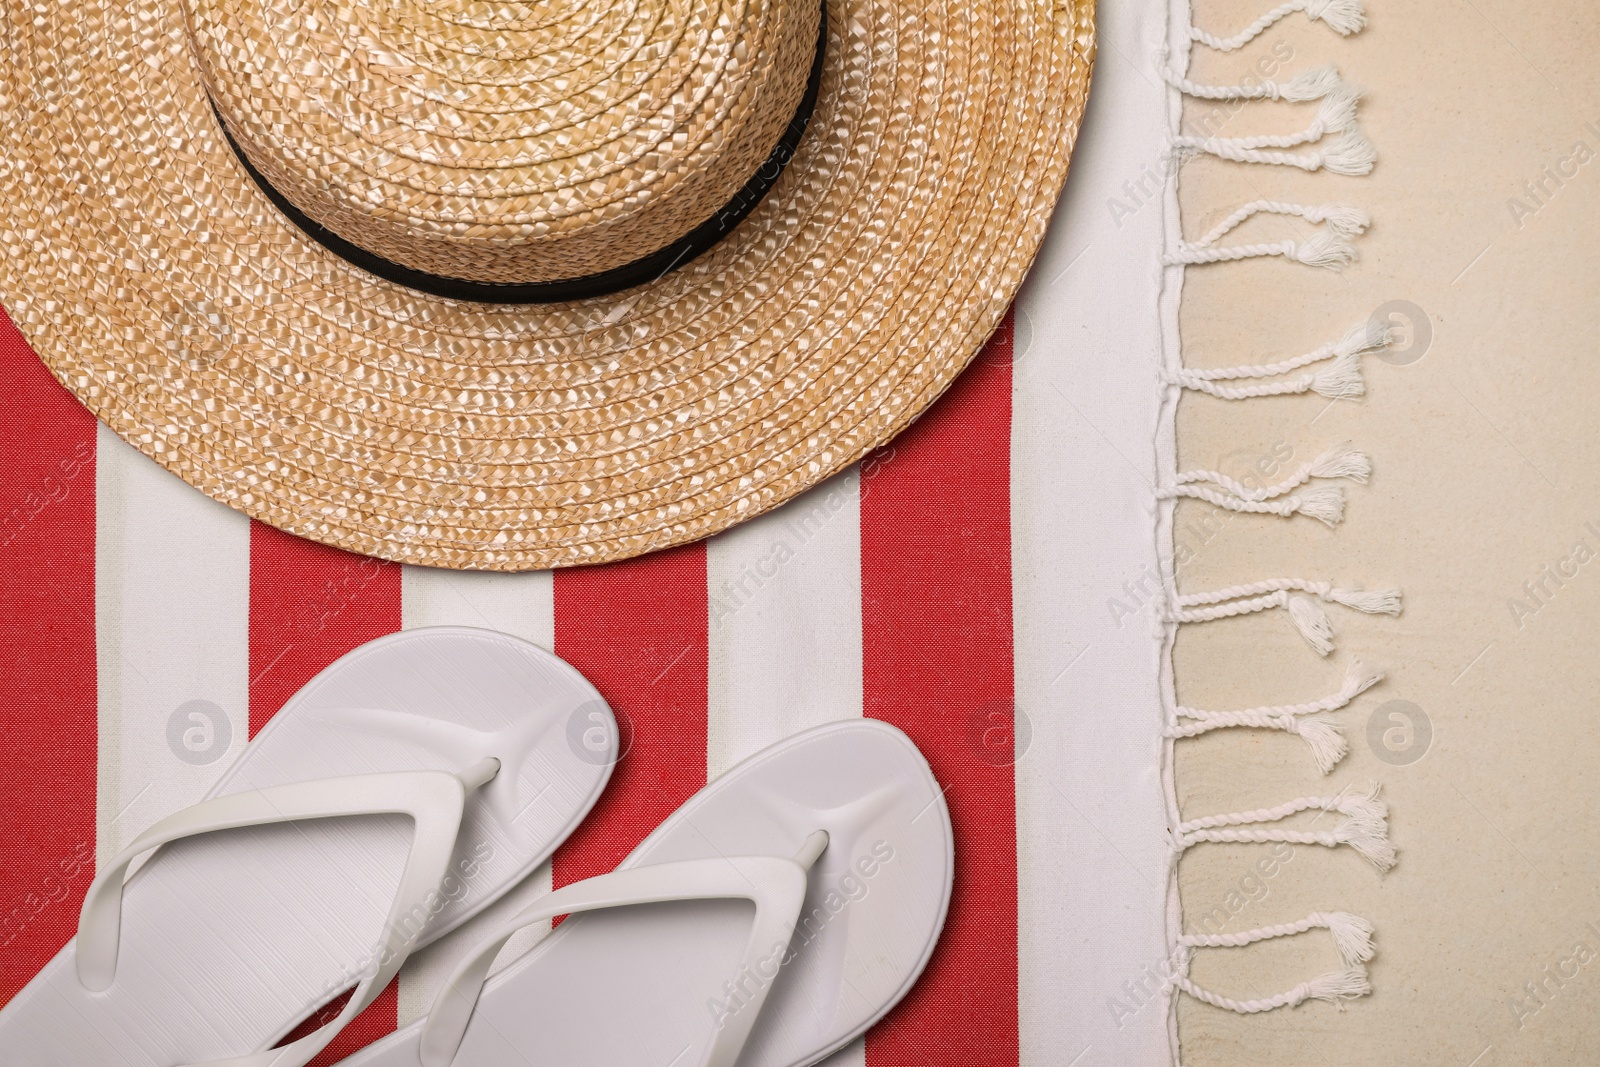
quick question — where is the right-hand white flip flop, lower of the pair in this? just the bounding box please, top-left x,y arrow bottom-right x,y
331,720 -> 954,1067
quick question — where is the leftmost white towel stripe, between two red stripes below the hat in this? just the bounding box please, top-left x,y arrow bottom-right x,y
94,424 -> 250,857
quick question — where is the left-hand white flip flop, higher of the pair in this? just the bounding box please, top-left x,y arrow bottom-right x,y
0,627 -> 618,1067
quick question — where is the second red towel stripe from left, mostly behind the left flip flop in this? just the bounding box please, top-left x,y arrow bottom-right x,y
250,523 -> 400,1067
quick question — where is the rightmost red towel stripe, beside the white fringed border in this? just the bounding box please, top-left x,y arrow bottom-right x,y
861,315 -> 1018,1067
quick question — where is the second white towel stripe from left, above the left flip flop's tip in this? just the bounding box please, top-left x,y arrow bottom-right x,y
397,566 -> 555,1025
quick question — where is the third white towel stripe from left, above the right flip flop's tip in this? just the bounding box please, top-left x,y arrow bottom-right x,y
706,467 -> 866,1067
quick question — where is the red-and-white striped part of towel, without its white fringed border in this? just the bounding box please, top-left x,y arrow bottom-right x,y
0,303 -> 1018,1064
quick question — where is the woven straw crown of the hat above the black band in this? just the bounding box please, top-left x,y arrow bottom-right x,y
187,0 -> 819,285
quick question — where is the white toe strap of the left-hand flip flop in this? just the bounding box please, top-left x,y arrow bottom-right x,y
75,760 -> 499,1067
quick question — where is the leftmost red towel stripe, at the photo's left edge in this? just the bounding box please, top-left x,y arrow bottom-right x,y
0,310 -> 98,1005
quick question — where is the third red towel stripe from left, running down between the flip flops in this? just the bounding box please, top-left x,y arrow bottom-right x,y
555,542 -> 709,886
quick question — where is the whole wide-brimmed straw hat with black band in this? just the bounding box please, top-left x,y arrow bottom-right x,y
0,0 -> 1094,569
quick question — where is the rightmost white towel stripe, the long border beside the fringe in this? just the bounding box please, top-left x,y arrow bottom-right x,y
1011,3 -> 1170,1067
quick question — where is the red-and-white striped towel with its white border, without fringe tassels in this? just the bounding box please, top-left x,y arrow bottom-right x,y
0,5 -> 1166,1067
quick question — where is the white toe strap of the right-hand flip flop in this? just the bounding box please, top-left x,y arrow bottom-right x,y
419,830 -> 827,1067
